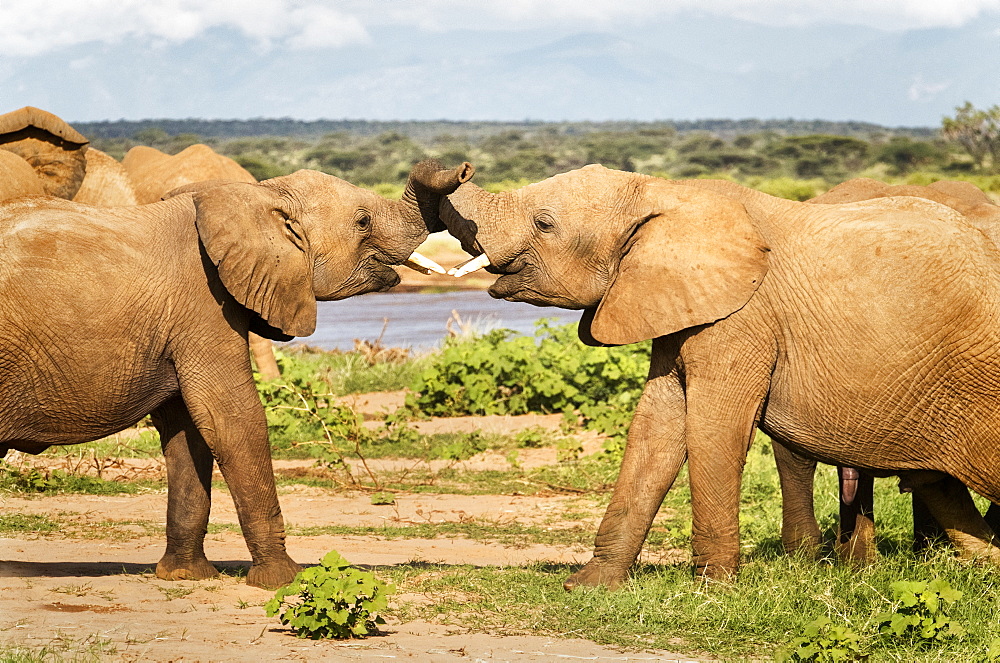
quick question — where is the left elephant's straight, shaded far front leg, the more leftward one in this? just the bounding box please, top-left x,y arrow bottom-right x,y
152,398 -> 219,580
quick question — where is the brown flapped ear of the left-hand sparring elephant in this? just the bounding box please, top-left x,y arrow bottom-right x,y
193,183 -> 316,336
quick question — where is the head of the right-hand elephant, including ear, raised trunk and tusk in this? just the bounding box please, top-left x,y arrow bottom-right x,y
440,165 -> 768,344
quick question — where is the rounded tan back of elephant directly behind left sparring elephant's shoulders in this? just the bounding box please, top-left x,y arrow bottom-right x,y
122,144 -> 257,204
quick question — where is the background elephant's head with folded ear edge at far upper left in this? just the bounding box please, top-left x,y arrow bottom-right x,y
0,106 -> 90,200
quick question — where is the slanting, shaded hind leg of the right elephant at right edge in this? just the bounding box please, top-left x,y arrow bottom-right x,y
902,477 -> 1000,564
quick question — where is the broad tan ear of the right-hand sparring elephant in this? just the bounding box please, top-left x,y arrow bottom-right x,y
580,180 -> 769,345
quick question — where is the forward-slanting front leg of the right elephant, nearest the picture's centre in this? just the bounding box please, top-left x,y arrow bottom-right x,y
563,339 -> 686,590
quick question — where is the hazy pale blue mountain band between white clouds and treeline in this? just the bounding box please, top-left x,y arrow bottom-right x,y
0,13 -> 1000,127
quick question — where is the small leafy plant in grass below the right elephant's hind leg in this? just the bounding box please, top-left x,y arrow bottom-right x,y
875,579 -> 965,646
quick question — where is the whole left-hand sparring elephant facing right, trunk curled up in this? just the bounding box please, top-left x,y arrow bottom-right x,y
0,161 -> 472,588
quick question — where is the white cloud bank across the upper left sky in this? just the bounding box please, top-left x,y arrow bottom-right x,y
0,0 -> 369,56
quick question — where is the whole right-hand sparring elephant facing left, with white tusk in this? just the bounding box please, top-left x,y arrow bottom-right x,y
435,165 -> 1000,589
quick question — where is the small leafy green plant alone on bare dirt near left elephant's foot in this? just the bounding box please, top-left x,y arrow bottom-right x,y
264,550 -> 396,640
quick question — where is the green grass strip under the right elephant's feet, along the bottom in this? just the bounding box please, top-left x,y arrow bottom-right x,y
380,551 -> 1000,661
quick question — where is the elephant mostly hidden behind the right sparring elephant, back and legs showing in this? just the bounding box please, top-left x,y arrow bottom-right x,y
760,177 -> 1000,562
